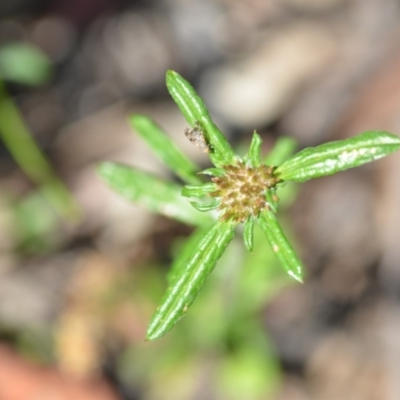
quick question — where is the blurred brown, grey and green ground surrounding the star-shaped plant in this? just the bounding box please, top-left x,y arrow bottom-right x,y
0,0 -> 400,400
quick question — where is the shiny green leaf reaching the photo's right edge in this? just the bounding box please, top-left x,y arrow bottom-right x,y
276,131 -> 400,182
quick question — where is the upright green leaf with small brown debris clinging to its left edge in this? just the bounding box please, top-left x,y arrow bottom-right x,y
166,70 -> 235,167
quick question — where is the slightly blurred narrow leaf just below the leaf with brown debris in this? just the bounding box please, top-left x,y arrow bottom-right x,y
129,115 -> 201,184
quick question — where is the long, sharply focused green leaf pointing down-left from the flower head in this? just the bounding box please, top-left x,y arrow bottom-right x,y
147,221 -> 234,340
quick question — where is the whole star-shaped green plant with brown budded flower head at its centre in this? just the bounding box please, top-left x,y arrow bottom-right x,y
100,71 -> 400,340
